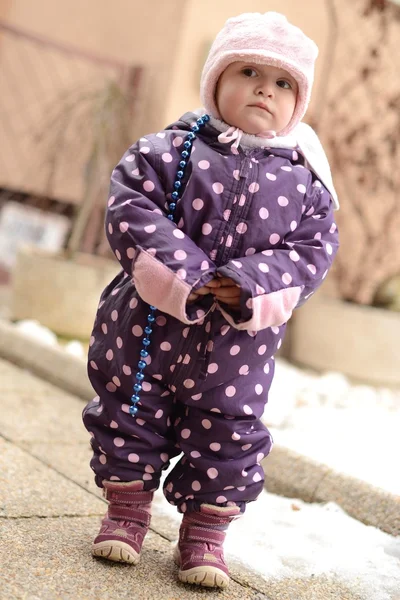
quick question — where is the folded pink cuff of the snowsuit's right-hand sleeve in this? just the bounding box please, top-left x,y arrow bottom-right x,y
219,287 -> 302,331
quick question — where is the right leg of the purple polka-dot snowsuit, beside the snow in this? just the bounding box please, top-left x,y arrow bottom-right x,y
164,358 -> 274,512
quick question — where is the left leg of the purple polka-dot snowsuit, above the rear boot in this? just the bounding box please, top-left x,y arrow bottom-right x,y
83,371 -> 180,491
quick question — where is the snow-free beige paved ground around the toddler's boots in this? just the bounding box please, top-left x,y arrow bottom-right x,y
0,360 -> 372,600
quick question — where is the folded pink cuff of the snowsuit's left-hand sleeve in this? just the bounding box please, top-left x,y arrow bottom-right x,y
132,249 -> 209,325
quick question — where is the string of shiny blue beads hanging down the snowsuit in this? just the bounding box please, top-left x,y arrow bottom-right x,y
129,115 -> 210,417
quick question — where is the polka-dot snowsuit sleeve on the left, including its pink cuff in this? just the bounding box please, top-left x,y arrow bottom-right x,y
106,136 -> 216,324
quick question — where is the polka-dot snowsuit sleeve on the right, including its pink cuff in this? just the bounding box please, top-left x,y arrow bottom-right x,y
218,182 -> 339,331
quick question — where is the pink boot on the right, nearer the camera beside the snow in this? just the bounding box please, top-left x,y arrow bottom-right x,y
174,504 -> 240,588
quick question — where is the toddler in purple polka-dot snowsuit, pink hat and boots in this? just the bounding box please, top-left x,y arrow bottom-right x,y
83,12 -> 338,588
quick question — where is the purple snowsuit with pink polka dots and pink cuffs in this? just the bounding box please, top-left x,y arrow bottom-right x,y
83,113 -> 338,512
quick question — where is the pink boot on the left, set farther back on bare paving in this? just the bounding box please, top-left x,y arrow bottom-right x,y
92,481 -> 153,565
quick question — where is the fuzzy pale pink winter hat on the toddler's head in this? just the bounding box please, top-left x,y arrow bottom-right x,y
200,12 -> 318,136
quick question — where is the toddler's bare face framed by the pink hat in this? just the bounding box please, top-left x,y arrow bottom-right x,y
216,62 -> 298,134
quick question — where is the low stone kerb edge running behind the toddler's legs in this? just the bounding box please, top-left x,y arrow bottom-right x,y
0,320 -> 400,535
